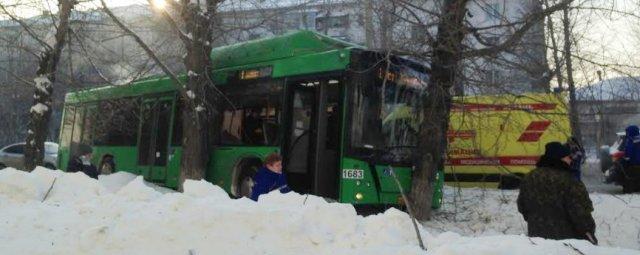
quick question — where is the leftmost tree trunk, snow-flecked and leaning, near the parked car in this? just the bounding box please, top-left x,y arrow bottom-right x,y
24,0 -> 75,171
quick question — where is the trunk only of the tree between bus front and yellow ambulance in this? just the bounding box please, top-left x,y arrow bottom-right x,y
411,0 -> 468,220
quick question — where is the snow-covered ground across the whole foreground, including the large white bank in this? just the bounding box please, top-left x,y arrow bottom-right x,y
0,168 -> 640,255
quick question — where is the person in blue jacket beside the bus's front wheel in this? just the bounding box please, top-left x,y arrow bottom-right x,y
251,153 -> 291,201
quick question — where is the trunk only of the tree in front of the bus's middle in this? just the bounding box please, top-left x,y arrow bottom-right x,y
179,1 -> 217,190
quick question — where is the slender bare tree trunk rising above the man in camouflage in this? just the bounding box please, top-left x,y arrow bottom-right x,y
562,6 -> 582,141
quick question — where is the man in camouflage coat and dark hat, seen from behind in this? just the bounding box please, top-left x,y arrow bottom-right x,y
517,142 -> 598,244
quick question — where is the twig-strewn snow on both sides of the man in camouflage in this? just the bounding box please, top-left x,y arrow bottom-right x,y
425,187 -> 640,249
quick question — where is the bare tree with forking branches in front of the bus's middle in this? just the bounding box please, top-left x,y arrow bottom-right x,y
101,0 -> 220,190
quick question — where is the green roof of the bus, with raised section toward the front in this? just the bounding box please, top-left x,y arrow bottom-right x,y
65,30 -> 362,103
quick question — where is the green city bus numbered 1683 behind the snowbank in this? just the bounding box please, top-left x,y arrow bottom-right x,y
59,31 -> 442,207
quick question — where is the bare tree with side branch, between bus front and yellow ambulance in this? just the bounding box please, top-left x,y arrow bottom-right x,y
411,0 -> 572,220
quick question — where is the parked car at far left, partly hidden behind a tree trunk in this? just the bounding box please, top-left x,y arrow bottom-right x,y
0,142 -> 58,169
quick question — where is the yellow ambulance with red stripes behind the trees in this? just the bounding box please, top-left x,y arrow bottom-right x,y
444,93 -> 571,188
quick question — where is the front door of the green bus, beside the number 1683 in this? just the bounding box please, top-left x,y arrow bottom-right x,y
283,79 -> 341,198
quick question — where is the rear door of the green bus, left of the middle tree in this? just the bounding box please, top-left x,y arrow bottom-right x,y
138,97 -> 173,181
